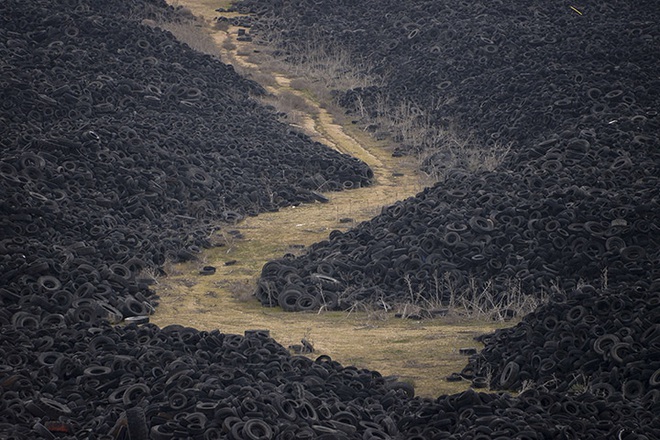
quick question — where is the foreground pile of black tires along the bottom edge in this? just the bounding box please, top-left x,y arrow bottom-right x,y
0,318 -> 660,440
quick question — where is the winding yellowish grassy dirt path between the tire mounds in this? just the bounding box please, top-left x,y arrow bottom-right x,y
151,0 -> 506,396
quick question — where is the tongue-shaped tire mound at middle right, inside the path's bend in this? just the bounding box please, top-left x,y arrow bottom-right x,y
256,163 -> 660,310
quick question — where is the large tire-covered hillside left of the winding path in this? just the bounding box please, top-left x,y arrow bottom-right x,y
0,1 -> 372,326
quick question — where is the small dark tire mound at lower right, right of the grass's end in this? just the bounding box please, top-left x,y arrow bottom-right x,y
462,282 -> 660,402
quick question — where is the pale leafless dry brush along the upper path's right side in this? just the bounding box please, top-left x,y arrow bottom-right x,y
250,22 -> 511,185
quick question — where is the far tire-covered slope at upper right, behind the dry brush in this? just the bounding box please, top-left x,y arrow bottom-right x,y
235,0 -> 660,163
